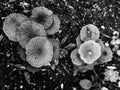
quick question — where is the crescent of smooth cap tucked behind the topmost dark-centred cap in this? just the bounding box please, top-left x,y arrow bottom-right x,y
46,14 -> 60,35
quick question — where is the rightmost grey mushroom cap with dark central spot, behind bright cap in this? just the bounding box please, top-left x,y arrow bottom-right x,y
98,46 -> 113,64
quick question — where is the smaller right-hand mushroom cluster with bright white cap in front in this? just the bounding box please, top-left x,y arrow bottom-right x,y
71,24 -> 113,72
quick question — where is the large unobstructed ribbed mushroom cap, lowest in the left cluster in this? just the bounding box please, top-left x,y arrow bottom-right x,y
26,37 -> 53,68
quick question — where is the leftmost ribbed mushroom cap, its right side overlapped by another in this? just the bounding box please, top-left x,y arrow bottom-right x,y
3,13 -> 28,41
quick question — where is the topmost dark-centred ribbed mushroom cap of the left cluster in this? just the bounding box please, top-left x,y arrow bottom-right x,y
31,7 -> 53,29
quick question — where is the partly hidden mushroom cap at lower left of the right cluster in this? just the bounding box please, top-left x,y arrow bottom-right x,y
70,49 -> 83,66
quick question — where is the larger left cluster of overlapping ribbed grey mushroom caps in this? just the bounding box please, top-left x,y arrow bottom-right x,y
3,7 -> 60,68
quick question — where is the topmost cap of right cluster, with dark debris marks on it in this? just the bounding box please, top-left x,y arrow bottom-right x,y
80,24 -> 100,41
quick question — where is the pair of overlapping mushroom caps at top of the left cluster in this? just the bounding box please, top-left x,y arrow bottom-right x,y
31,7 -> 60,35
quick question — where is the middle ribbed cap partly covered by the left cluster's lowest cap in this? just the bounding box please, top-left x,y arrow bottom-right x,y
16,21 -> 46,48
